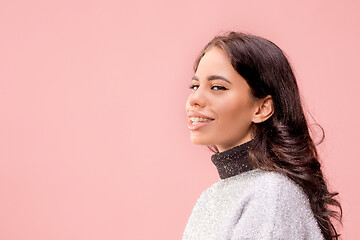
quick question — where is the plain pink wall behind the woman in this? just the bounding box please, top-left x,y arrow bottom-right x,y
0,0 -> 360,240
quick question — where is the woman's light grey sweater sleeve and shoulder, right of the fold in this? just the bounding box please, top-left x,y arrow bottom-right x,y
234,171 -> 323,239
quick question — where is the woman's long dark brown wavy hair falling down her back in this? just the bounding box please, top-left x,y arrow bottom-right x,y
194,32 -> 342,240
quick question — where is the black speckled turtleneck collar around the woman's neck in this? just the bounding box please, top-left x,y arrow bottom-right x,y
211,140 -> 254,179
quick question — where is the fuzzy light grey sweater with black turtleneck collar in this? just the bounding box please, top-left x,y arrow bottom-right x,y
183,142 -> 324,240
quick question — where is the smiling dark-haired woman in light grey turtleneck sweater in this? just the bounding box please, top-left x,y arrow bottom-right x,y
183,32 -> 342,240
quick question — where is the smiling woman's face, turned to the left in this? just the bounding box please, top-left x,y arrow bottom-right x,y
186,47 -> 257,151
